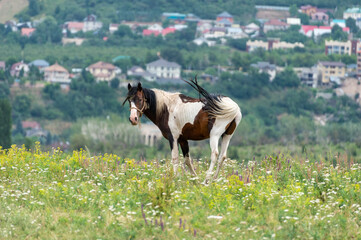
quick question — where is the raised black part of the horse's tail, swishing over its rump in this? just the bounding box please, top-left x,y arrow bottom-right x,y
184,76 -> 222,116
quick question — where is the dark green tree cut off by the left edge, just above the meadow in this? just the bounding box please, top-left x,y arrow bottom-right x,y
0,99 -> 11,148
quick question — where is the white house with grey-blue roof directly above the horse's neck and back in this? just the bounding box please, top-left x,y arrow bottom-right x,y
146,58 -> 181,79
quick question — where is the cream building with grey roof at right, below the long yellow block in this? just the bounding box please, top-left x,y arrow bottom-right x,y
317,61 -> 346,86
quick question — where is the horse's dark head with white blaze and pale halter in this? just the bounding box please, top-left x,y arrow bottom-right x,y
123,83 -> 147,125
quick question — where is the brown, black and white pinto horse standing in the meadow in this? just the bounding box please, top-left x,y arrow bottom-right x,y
123,77 -> 242,184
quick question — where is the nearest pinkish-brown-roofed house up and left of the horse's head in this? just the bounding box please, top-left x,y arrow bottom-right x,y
86,61 -> 121,82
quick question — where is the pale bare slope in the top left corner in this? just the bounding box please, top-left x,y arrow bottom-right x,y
0,0 -> 29,23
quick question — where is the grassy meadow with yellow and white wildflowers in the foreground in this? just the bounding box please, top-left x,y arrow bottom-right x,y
0,143 -> 361,239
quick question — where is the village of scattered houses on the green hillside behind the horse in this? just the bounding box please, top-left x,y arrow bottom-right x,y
0,5 -> 361,148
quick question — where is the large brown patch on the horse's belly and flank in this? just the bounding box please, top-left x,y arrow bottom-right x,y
182,108 -> 215,140
